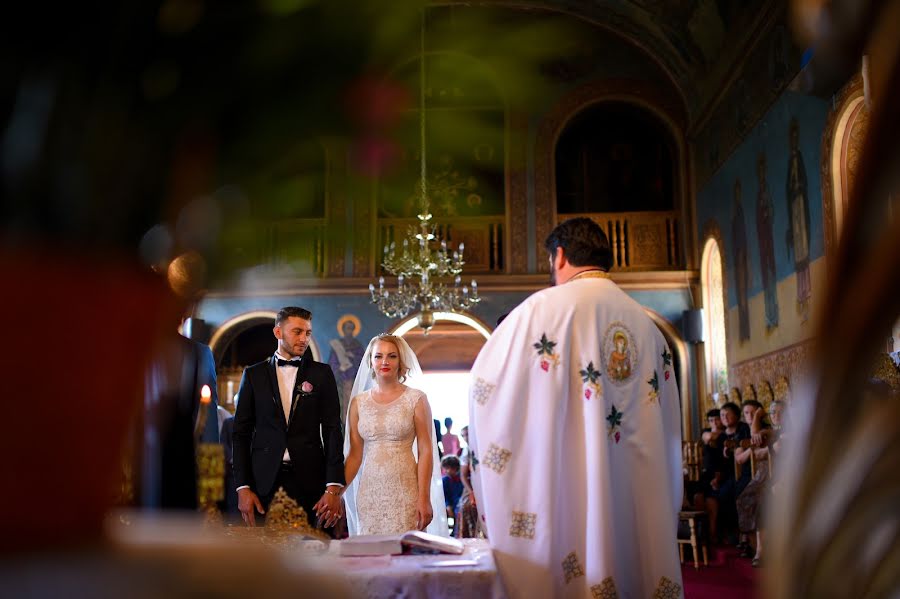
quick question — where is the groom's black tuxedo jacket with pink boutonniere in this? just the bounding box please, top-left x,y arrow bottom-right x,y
232,356 -> 344,501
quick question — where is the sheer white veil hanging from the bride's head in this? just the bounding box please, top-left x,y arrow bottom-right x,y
344,335 -> 450,537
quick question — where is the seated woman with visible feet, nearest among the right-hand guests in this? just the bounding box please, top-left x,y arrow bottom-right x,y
735,400 -> 771,565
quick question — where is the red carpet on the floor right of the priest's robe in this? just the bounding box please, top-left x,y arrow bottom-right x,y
681,547 -> 761,599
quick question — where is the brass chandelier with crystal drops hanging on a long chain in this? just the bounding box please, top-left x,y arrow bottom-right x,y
369,10 -> 481,335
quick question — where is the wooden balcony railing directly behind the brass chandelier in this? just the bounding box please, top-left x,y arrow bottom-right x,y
376,216 -> 506,273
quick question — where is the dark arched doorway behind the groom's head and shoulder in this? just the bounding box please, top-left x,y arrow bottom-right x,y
209,310 -> 321,412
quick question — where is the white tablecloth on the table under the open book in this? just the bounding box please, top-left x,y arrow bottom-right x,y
304,539 -> 506,599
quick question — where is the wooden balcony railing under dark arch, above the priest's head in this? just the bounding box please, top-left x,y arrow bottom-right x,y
557,211 -> 682,270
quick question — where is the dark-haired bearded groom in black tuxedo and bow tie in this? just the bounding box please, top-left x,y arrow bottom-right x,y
232,307 -> 344,526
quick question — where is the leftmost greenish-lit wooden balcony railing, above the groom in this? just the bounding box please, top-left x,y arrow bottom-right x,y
261,218 -> 326,277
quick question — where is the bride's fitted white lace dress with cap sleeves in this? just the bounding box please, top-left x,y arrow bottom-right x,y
355,387 -> 427,535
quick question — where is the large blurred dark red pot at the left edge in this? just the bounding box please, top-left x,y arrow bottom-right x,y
0,248 -> 182,552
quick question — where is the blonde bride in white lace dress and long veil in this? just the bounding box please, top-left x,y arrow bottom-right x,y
344,334 -> 449,536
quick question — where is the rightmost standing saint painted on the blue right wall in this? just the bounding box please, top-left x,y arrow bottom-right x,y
786,118 -> 812,321
